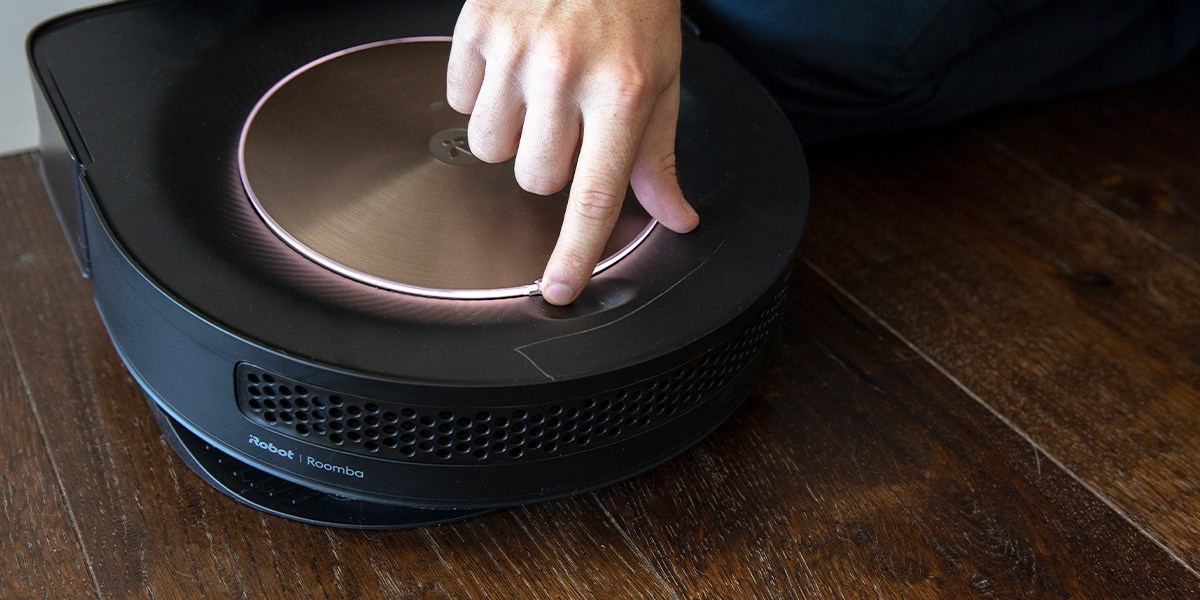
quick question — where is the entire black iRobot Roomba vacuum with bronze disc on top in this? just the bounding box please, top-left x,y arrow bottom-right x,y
29,0 -> 808,528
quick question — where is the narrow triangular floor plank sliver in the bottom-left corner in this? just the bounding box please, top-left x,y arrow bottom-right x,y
0,157 -> 97,598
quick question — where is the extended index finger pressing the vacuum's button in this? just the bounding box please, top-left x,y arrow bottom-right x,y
541,102 -> 649,306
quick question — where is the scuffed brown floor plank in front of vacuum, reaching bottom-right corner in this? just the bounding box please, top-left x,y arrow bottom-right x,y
600,265 -> 1200,598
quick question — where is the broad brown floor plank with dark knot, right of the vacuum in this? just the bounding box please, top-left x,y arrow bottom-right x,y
804,103 -> 1200,570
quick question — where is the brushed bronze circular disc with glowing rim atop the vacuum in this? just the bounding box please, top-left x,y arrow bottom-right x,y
239,37 -> 654,299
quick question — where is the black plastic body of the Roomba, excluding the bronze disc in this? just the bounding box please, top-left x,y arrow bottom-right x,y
29,0 -> 808,527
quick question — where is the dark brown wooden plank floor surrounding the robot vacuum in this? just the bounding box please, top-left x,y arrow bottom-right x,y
0,55 -> 1200,599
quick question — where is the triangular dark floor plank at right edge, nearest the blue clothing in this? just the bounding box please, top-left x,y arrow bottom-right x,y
973,55 -> 1200,266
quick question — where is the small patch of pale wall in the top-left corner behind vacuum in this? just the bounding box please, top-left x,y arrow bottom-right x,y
0,0 -> 101,155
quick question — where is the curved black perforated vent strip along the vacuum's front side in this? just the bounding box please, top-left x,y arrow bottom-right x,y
236,287 -> 786,464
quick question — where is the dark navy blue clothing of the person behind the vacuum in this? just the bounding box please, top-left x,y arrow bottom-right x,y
684,0 -> 1200,143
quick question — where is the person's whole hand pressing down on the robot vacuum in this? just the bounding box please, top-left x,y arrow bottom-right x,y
446,0 -> 700,305
